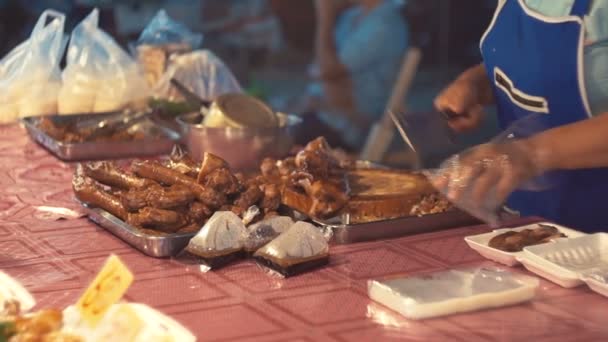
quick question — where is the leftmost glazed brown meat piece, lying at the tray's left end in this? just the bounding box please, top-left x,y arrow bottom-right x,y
72,172 -> 127,220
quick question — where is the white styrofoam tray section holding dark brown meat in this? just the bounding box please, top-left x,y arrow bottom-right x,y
464,222 -> 586,266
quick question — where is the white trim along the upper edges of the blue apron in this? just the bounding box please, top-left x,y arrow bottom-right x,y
479,0 -> 592,117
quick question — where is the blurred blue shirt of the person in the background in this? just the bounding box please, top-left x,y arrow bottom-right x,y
320,0 -> 408,145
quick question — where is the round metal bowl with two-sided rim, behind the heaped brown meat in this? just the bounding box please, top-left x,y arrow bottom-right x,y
177,113 -> 302,170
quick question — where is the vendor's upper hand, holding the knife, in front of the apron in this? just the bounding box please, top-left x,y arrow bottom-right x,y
435,79 -> 485,132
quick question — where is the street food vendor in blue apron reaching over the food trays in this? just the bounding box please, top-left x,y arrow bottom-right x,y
433,0 -> 608,231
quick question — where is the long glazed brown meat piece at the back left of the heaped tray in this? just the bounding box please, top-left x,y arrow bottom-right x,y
83,161 -> 155,190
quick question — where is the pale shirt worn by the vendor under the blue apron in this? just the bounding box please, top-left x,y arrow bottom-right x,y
506,0 -> 608,115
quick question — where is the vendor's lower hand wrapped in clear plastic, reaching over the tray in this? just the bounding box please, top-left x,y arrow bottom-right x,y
430,140 -> 545,216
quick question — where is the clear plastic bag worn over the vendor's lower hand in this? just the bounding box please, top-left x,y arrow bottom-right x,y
425,114 -> 563,227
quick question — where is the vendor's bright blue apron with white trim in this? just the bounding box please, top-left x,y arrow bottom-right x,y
480,0 -> 608,232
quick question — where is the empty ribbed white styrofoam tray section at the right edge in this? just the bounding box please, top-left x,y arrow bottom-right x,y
519,233 -> 608,295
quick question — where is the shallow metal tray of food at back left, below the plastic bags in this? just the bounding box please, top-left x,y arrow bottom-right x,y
21,114 -> 180,161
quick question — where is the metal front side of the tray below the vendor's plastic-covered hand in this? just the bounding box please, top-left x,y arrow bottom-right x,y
315,210 -> 481,245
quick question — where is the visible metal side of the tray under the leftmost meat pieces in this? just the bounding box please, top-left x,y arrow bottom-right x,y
83,204 -> 195,258
